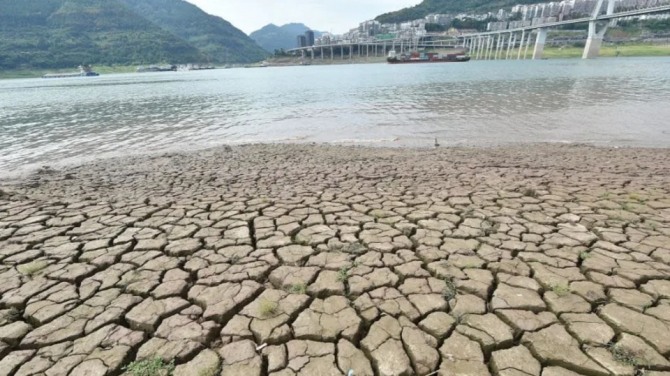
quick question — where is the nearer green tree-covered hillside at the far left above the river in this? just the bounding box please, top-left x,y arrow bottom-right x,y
0,0 -> 203,69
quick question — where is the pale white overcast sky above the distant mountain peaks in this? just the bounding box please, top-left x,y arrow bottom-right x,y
187,0 -> 421,34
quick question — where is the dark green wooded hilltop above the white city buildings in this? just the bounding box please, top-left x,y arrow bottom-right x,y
375,0 -> 547,23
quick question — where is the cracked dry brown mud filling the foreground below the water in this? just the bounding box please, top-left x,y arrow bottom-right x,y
0,145 -> 670,376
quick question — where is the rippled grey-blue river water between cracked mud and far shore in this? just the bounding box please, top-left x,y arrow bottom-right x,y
0,58 -> 670,177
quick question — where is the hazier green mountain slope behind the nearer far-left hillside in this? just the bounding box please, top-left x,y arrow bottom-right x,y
119,0 -> 267,63
